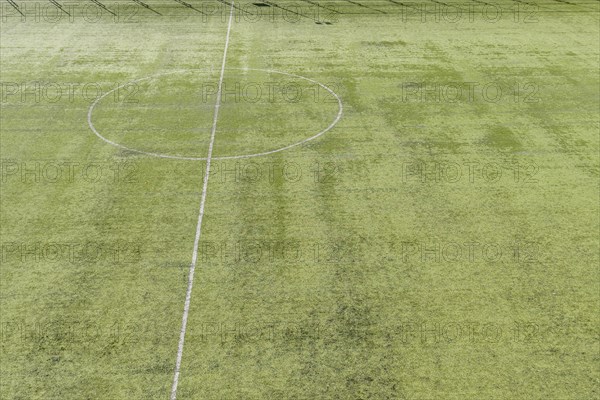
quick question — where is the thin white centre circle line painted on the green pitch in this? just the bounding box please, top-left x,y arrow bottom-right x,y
88,68 -> 344,161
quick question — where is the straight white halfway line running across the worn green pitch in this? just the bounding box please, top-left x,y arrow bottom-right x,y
171,0 -> 234,400
